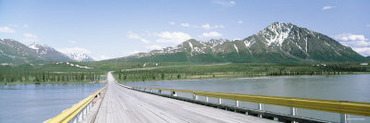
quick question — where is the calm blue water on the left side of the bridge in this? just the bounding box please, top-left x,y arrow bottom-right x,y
0,84 -> 105,123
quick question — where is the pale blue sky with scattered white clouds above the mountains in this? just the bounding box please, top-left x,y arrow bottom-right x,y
0,0 -> 370,60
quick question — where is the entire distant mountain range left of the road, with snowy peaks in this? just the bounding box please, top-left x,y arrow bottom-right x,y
0,39 -> 93,64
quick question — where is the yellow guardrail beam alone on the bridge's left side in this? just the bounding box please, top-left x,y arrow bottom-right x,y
46,85 -> 107,123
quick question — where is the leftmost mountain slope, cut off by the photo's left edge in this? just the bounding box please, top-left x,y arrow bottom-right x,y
0,39 -> 44,64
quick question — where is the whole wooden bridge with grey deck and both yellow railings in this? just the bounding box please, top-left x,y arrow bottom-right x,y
46,73 -> 370,123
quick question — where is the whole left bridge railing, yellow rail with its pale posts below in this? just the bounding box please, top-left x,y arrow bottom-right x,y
46,85 -> 108,123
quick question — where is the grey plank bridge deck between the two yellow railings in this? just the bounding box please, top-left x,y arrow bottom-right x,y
95,74 -> 274,123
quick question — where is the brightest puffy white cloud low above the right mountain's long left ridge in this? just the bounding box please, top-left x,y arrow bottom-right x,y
156,32 -> 191,44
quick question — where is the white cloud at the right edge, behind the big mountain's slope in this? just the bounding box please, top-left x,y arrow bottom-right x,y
334,33 -> 370,56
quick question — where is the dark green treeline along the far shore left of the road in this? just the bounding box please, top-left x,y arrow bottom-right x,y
0,71 -> 100,82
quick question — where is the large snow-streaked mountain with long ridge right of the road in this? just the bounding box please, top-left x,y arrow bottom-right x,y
114,22 -> 366,63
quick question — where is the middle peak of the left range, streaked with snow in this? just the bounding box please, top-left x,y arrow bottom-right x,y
29,43 -> 74,62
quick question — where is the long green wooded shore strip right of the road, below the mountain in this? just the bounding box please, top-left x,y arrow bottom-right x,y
114,64 -> 368,81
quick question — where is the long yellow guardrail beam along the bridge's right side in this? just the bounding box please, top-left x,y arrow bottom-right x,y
133,87 -> 370,116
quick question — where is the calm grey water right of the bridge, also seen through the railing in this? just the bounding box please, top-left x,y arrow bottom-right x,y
123,74 -> 370,122
